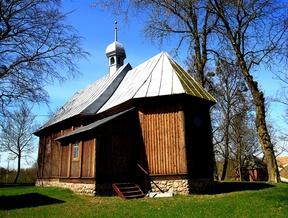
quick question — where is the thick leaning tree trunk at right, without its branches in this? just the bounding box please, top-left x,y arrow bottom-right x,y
210,1 -> 280,183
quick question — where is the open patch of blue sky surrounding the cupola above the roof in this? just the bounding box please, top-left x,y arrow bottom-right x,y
35,0 -> 173,122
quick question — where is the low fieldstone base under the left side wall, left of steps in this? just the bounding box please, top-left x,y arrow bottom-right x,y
35,179 -> 96,196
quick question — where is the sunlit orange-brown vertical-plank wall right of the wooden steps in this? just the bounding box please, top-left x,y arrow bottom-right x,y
139,107 -> 187,175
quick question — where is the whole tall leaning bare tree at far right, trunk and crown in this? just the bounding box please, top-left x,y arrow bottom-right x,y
209,0 -> 288,182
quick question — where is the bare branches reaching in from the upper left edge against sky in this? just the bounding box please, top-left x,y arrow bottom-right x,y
0,0 -> 86,110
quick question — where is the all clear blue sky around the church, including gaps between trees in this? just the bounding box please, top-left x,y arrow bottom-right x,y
0,0 -> 285,167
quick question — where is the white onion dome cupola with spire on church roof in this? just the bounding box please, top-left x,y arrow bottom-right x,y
106,21 -> 126,76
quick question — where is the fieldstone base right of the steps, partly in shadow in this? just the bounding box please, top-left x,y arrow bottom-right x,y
150,178 -> 213,195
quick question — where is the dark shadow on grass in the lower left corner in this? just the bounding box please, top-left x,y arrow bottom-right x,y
0,193 -> 65,210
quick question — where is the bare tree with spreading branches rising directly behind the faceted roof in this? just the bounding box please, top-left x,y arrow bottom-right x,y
95,0 -> 220,87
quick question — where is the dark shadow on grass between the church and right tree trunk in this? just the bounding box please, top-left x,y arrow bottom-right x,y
192,182 -> 274,195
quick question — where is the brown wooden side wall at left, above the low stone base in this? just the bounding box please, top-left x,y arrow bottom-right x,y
38,128 -> 95,178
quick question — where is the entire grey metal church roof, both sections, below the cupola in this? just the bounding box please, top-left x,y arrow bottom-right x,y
41,52 -> 216,129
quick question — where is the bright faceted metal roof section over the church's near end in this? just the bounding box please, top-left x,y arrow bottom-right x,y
98,52 -> 216,113
